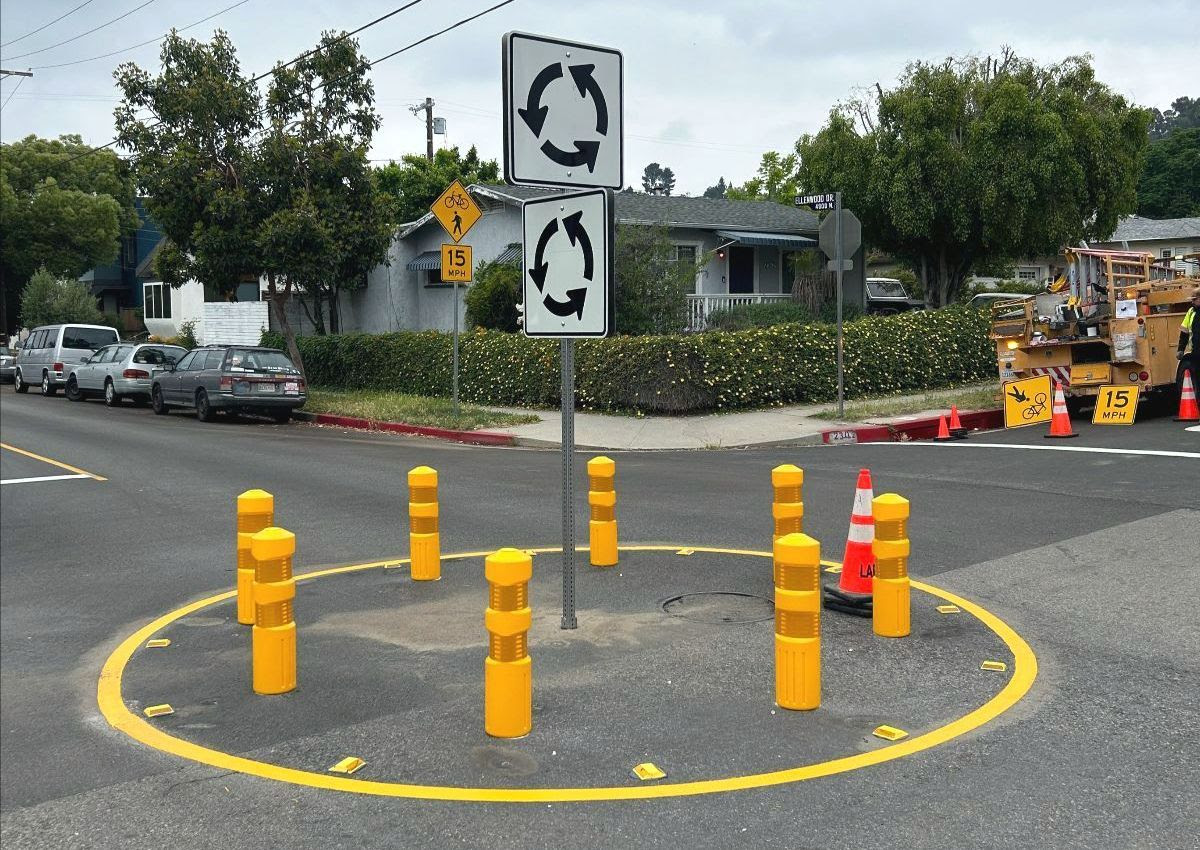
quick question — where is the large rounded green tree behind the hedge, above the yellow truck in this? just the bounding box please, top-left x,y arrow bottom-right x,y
797,50 -> 1150,306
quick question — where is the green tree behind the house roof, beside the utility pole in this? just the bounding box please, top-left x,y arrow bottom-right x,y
376,145 -> 500,226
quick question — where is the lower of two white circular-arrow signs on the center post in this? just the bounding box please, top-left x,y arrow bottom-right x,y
521,188 -> 614,339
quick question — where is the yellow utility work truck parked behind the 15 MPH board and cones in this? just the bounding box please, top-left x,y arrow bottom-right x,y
991,249 -> 1200,417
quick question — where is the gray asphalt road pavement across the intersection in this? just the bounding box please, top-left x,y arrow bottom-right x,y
0,388 -> 1200,848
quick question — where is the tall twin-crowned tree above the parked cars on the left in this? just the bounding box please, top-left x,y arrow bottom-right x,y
115,31 -> 390,370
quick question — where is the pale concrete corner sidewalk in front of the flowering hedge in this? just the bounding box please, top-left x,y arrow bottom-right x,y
490,388 -> 998,450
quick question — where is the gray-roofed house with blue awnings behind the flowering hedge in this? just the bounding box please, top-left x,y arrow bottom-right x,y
343,185 -> 844,333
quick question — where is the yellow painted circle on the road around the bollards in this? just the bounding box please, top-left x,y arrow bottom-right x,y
96,544 -> 1038,803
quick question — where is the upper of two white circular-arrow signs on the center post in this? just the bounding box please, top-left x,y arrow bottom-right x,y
502,32 -> 625,188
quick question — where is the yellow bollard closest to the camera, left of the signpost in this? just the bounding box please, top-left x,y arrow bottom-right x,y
484,549 -> 533,738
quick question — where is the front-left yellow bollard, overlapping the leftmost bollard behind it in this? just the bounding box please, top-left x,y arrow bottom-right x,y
250,527 -> 296,694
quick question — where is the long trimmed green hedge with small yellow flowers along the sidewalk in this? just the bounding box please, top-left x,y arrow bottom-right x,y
263,307 -> 996,413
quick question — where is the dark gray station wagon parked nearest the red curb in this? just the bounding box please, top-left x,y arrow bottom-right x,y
150,346 -> 306,423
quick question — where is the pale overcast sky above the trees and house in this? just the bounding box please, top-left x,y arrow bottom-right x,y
0,0 -> 1200,193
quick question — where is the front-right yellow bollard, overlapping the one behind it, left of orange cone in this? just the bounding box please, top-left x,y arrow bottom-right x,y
774,533 -> 821,711
